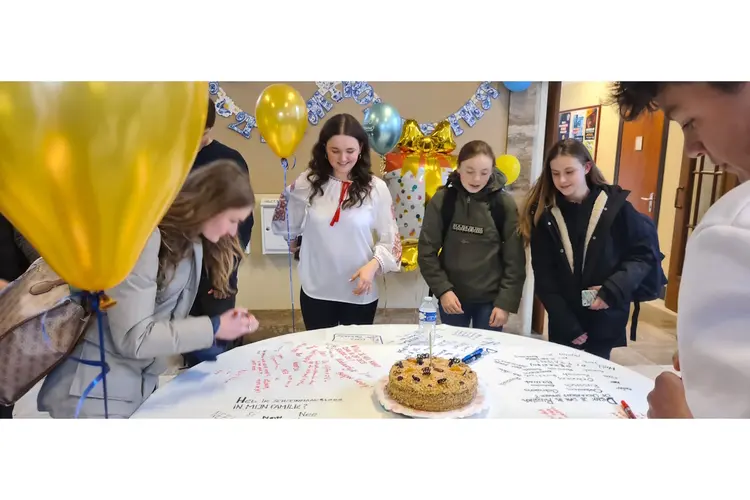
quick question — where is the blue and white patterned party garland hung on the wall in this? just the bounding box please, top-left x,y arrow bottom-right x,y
208,82 -> 500,142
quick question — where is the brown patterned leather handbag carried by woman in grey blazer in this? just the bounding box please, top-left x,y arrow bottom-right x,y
0,259 -> 92,406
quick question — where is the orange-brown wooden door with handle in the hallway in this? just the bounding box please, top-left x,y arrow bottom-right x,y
615,111 -> 668,223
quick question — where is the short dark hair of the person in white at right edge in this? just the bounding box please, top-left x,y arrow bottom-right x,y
607,82 -> 745,121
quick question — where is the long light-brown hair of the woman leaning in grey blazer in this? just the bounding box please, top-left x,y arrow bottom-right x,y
157,160 -> 255,299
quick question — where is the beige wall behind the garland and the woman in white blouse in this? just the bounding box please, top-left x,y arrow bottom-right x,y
214,82 -> 509,309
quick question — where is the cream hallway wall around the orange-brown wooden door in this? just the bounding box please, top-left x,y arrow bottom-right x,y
560,82 -> 683,273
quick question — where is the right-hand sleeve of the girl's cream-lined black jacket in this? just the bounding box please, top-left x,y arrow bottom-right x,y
599,202 -> 656,307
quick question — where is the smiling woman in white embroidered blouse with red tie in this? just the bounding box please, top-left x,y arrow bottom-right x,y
273,114 -> 401,330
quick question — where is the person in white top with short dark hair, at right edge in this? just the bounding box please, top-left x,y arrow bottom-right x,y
611,82 -> 750,418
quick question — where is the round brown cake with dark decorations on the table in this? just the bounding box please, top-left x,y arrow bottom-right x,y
386,354 -> 478,412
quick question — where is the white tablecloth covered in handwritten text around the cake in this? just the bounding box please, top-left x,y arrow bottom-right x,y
154,328 -> 645,419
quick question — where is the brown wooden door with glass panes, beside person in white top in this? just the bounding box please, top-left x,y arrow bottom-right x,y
664,156 -> 739,312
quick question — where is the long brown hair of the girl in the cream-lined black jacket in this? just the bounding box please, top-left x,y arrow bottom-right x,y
518,139 -> 607,245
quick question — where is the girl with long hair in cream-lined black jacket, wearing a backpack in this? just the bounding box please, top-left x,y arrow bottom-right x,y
520,139 -> 656,359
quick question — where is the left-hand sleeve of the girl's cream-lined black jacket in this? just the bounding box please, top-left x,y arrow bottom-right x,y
531,228 -> 585,341
